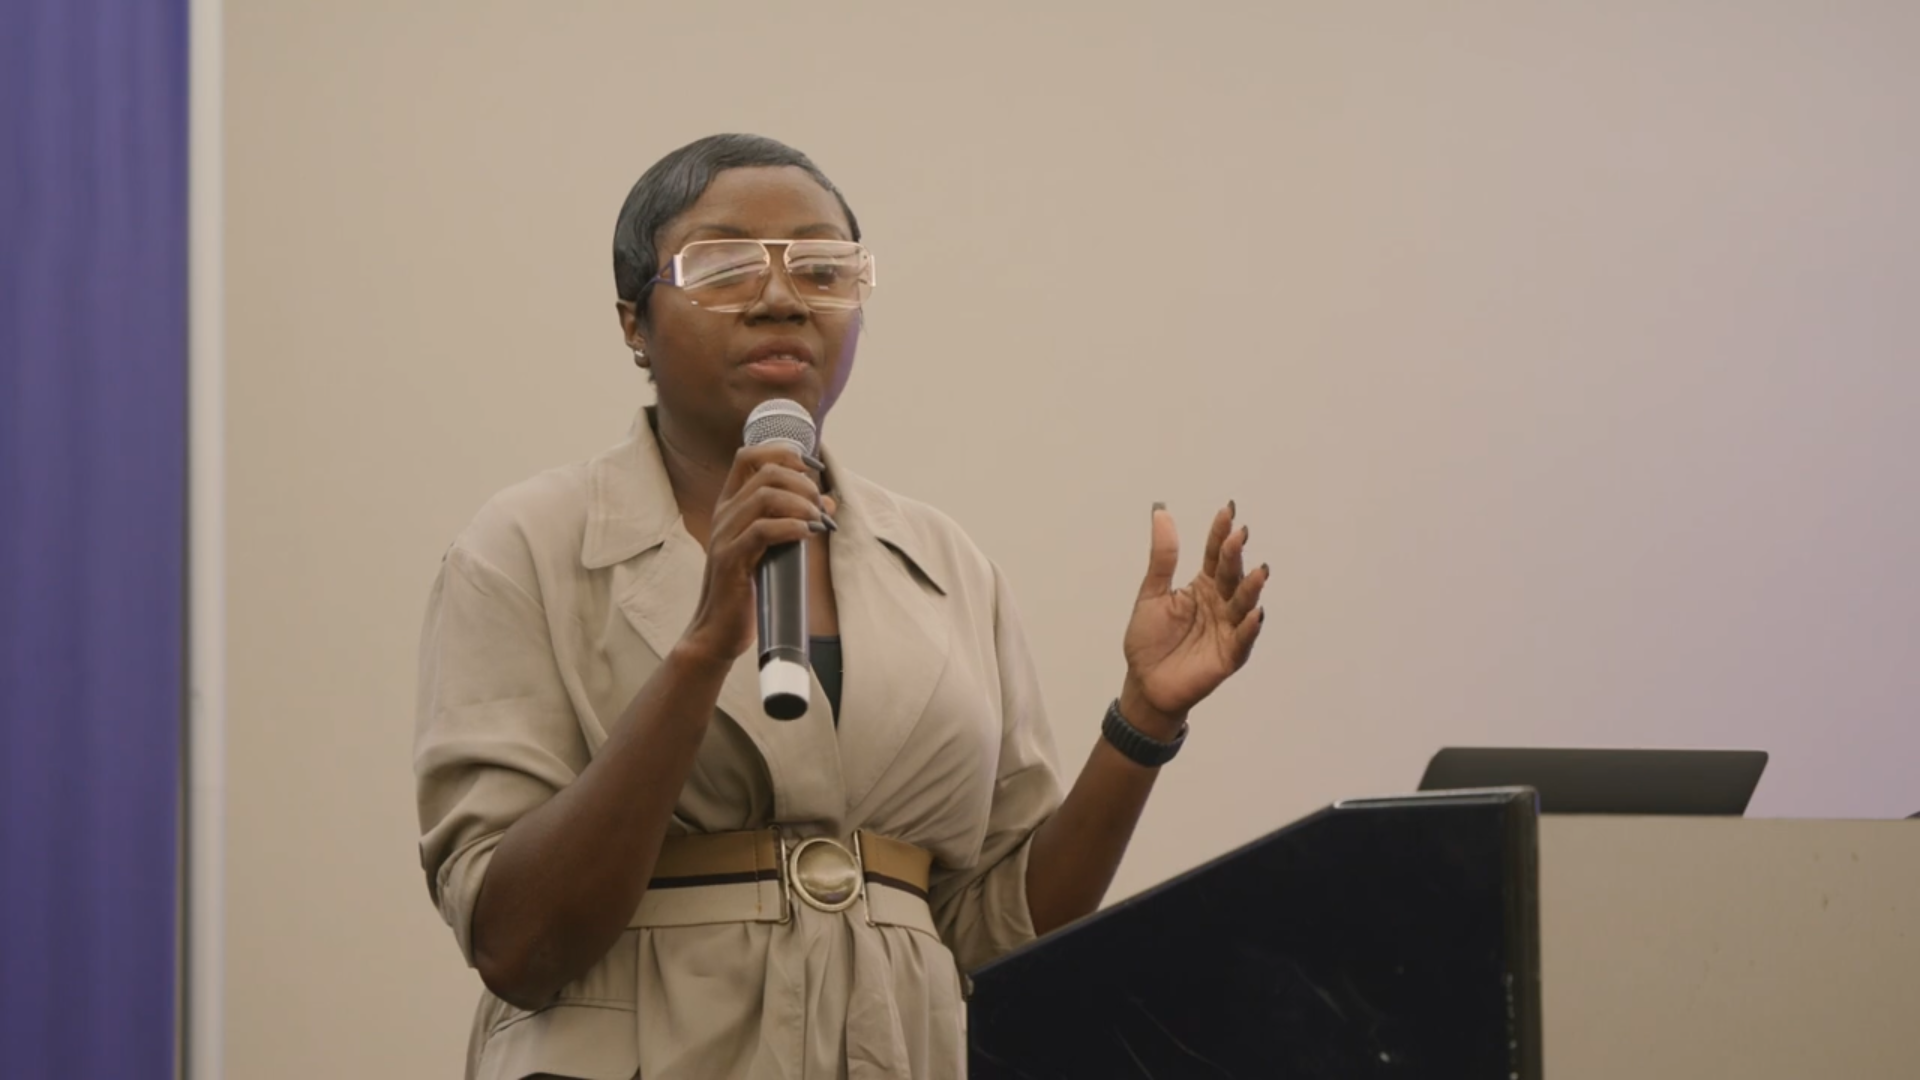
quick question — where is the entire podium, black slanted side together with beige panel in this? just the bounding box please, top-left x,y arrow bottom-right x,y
970,790 -> 1920,1080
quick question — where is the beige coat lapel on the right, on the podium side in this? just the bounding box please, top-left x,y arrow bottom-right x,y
824,455 -> 950,824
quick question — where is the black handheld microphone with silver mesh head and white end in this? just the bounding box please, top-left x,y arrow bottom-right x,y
747,398 -> 816,721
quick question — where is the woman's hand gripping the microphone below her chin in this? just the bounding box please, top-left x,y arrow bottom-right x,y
680,444 -> 828,665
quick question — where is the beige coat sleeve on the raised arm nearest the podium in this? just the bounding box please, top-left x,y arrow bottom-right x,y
931,567 -> 1062,970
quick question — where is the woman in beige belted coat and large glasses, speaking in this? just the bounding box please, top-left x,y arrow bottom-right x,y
415,136 -> 1267,1080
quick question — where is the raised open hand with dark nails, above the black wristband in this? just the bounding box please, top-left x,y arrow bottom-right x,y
1119,503 -> 1269,740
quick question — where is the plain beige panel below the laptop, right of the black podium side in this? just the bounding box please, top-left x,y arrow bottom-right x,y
1540,815 -> 1920,1080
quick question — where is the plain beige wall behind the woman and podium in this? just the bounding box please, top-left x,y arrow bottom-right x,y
227,0 -> 1920,1080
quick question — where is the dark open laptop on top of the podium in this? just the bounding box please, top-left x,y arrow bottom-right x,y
1421,746 -> 1766,817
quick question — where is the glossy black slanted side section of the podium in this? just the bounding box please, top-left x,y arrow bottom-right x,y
970,790 -> 1540,1080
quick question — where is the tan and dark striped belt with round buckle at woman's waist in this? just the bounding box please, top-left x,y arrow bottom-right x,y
632,828 -> 937,936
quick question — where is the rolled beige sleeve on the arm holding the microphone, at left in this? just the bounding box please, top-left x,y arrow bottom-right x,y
413,544 -> 588,965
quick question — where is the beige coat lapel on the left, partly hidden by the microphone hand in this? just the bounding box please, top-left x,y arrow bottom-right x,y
580,415 -> 847,822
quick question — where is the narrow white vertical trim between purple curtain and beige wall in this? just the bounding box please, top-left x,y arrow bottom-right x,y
179,0 -> 227,1080
